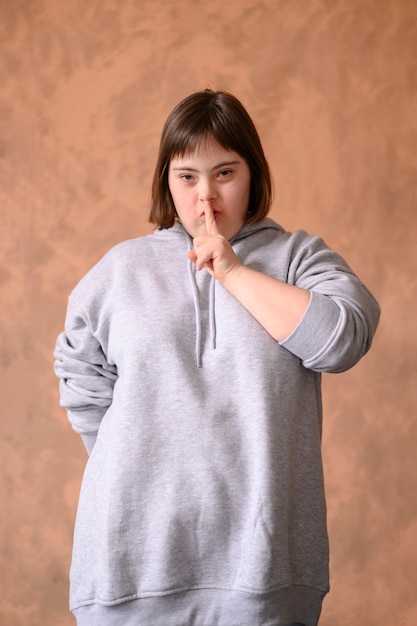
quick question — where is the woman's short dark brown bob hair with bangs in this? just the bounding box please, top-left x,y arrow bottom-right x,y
149,89 -> 272,228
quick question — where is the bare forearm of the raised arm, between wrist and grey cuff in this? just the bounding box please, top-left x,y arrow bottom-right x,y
221,264 -> 310,341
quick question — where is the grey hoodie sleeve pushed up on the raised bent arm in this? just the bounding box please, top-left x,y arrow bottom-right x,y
281,231 -> 380,373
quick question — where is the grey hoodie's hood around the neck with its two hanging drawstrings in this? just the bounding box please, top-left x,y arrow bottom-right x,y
154,218 -> 285,367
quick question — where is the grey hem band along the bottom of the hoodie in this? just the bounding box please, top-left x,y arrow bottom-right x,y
72,585 -> 328,626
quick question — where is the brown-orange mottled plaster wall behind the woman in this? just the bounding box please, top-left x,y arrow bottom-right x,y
0,0 -> 417,626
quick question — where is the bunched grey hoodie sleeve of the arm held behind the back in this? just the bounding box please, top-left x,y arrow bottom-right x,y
54,290 -> 117,452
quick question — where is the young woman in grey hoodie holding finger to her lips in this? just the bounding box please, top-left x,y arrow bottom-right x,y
55,90 -> 379,626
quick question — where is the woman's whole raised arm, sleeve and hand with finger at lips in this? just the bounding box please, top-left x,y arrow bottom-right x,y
188,204 -> 380,372
